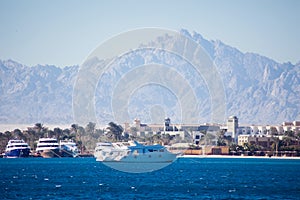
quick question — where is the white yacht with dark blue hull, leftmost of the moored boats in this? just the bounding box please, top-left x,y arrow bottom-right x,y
4,140 -> 30,158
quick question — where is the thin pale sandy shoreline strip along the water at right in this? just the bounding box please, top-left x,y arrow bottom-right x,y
177,155 -> 300,160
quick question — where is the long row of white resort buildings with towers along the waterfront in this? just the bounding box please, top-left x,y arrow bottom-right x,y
126,116 -> 300,147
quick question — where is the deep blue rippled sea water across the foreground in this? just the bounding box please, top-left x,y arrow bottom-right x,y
0,158 -> 300,199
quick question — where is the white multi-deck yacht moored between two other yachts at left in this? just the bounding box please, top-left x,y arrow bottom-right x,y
35,138 -> 61,158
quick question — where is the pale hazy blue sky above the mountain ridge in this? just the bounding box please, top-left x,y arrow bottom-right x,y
0,0 -> 300,67
